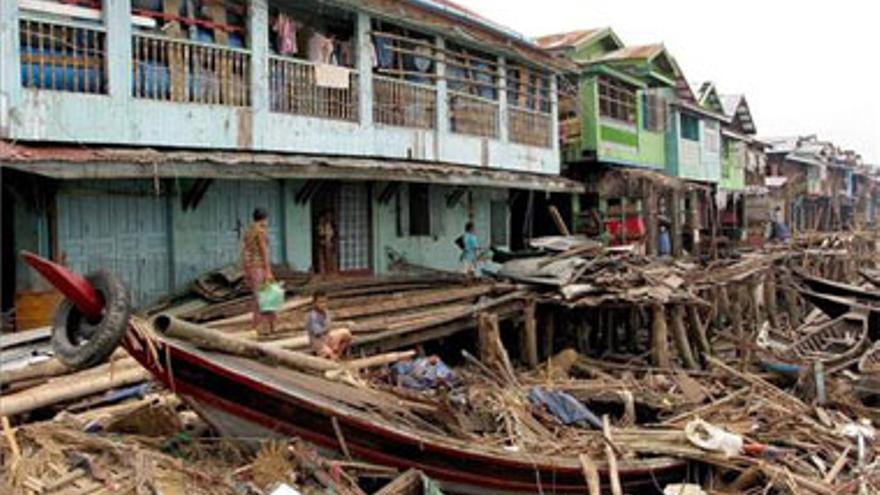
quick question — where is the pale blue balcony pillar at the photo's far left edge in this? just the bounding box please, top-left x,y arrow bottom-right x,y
0,0 -> 22,138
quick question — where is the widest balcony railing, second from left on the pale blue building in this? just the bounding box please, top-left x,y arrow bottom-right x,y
132,33 -> 251,107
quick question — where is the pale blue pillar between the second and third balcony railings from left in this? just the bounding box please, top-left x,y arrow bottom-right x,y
247,0 -> 271,149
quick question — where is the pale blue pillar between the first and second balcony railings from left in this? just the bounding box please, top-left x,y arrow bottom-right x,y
104,0 -> 132,100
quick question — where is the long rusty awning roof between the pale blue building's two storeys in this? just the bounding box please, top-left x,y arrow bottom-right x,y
0,141 -> 584,192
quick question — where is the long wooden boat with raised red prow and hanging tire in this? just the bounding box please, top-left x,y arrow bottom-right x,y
25,255 -> 688,494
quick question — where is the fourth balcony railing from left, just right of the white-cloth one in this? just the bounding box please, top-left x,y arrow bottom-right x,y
373,76 -> 437,129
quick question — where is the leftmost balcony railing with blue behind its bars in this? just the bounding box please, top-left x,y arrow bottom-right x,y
19,16 -> 107,93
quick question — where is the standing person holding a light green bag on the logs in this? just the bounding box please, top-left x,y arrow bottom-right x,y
241,208 -> 275,335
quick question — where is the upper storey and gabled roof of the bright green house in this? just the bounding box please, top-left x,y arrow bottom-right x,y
536,28 -> 679,170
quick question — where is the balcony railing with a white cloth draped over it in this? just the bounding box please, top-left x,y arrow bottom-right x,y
269,56 -> 359,122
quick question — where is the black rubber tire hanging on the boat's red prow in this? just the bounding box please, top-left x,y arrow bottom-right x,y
52,270 -> 131,370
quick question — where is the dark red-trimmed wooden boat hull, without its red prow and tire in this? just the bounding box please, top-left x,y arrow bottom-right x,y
124,331 -> 688,494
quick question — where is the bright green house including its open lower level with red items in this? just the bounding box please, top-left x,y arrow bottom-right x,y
536,28 -> 678,252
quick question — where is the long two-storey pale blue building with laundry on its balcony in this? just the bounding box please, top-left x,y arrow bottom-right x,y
0,0 -> 579,307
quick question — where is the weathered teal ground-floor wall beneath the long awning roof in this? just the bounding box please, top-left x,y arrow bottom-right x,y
14,176 -> 509,304
